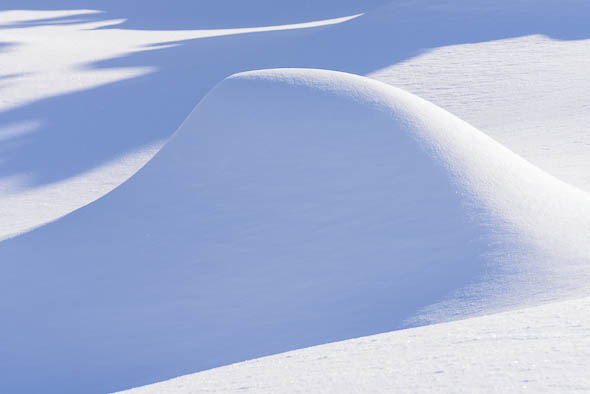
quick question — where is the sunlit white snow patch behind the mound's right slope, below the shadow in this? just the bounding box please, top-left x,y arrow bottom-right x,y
369,35 -> 590,190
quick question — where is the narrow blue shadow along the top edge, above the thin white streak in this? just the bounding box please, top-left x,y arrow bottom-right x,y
0,0 -> 391,30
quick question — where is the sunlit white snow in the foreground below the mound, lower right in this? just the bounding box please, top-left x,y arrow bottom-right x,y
118,298 -> 590,394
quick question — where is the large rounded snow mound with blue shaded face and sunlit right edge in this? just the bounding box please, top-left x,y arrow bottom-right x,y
0,69 -> 590,393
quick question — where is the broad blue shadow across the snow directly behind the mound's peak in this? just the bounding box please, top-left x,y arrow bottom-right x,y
0,0 -> 590,186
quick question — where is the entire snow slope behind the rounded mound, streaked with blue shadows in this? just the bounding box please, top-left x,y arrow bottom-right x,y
0,0 -> 590,239
